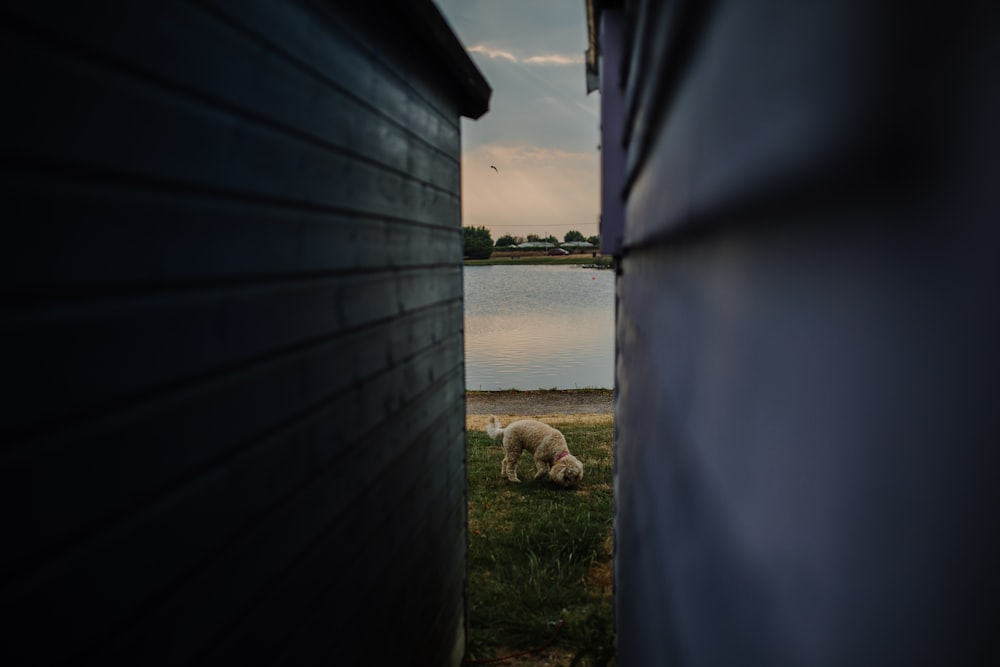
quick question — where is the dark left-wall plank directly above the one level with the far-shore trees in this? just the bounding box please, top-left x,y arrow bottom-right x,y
0,35 -> 460,219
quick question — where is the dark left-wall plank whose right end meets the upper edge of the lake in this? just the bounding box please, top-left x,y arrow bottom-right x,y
0,267 -> 462,441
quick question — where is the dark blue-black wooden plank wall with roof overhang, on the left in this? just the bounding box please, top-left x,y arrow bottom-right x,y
0,0 -> 489,665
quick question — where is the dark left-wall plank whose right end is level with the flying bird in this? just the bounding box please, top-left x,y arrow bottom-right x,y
5,5 -> 459,170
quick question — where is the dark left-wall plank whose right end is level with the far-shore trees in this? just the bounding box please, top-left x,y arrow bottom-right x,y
0,176 -> 462,296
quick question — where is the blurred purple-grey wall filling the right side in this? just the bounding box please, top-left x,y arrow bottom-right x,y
597,1 -> 1000,667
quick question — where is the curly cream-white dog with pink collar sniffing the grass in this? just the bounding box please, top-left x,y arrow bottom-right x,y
486,415 -> 583,486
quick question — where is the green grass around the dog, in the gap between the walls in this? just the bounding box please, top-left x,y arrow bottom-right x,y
466,417 -> 614,665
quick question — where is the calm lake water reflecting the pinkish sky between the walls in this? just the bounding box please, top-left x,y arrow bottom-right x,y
463,265 -> 615,390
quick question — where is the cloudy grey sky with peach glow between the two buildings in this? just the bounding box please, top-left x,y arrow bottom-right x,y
435,0 -> 600,241
